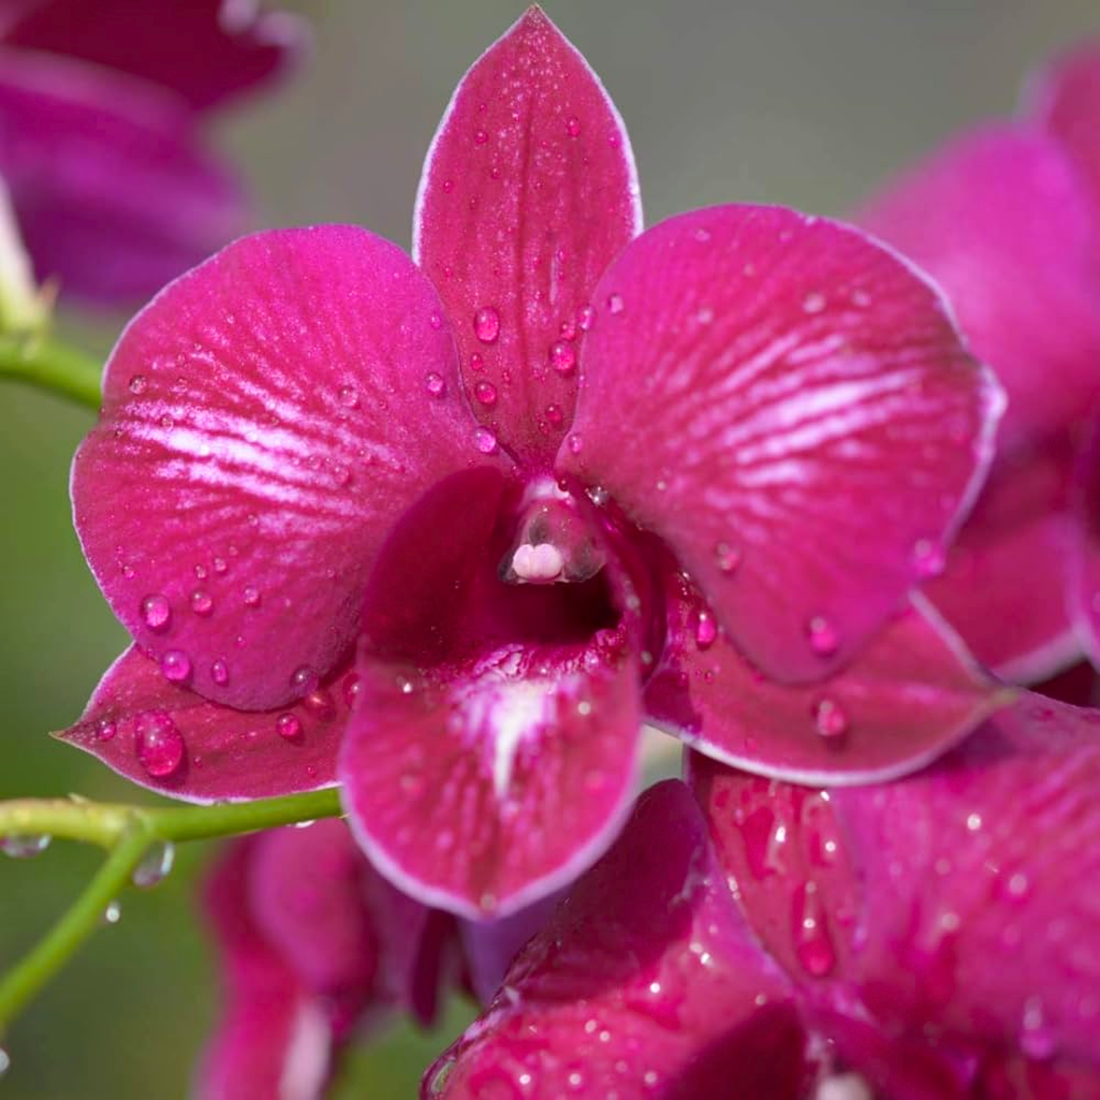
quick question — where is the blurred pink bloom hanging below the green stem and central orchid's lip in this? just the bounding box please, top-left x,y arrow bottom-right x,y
198,821 -> 550,1100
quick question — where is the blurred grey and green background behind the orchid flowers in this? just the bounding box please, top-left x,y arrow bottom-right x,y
0,0 -> 1100,1100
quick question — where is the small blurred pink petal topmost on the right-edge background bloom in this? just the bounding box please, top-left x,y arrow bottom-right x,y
1027,37 -> 1100,223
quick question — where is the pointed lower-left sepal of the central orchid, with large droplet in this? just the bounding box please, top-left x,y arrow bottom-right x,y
59,647 -> 347,802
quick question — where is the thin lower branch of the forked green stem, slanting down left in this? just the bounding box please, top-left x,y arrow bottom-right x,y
0,828 -> 152,1032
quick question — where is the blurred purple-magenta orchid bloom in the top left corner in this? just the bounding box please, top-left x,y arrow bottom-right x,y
0,0 -> 305,304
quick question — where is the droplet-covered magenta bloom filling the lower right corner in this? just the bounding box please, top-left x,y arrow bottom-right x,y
424,696 -> 1100,1100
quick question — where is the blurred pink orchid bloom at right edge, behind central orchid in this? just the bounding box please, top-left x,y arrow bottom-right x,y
859,40 -> 1100,682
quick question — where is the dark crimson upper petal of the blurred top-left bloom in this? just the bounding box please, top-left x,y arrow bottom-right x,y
3,0 -> 308,109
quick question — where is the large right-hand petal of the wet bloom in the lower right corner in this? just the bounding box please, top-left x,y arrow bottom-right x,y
831,695 -> 1100,1062
